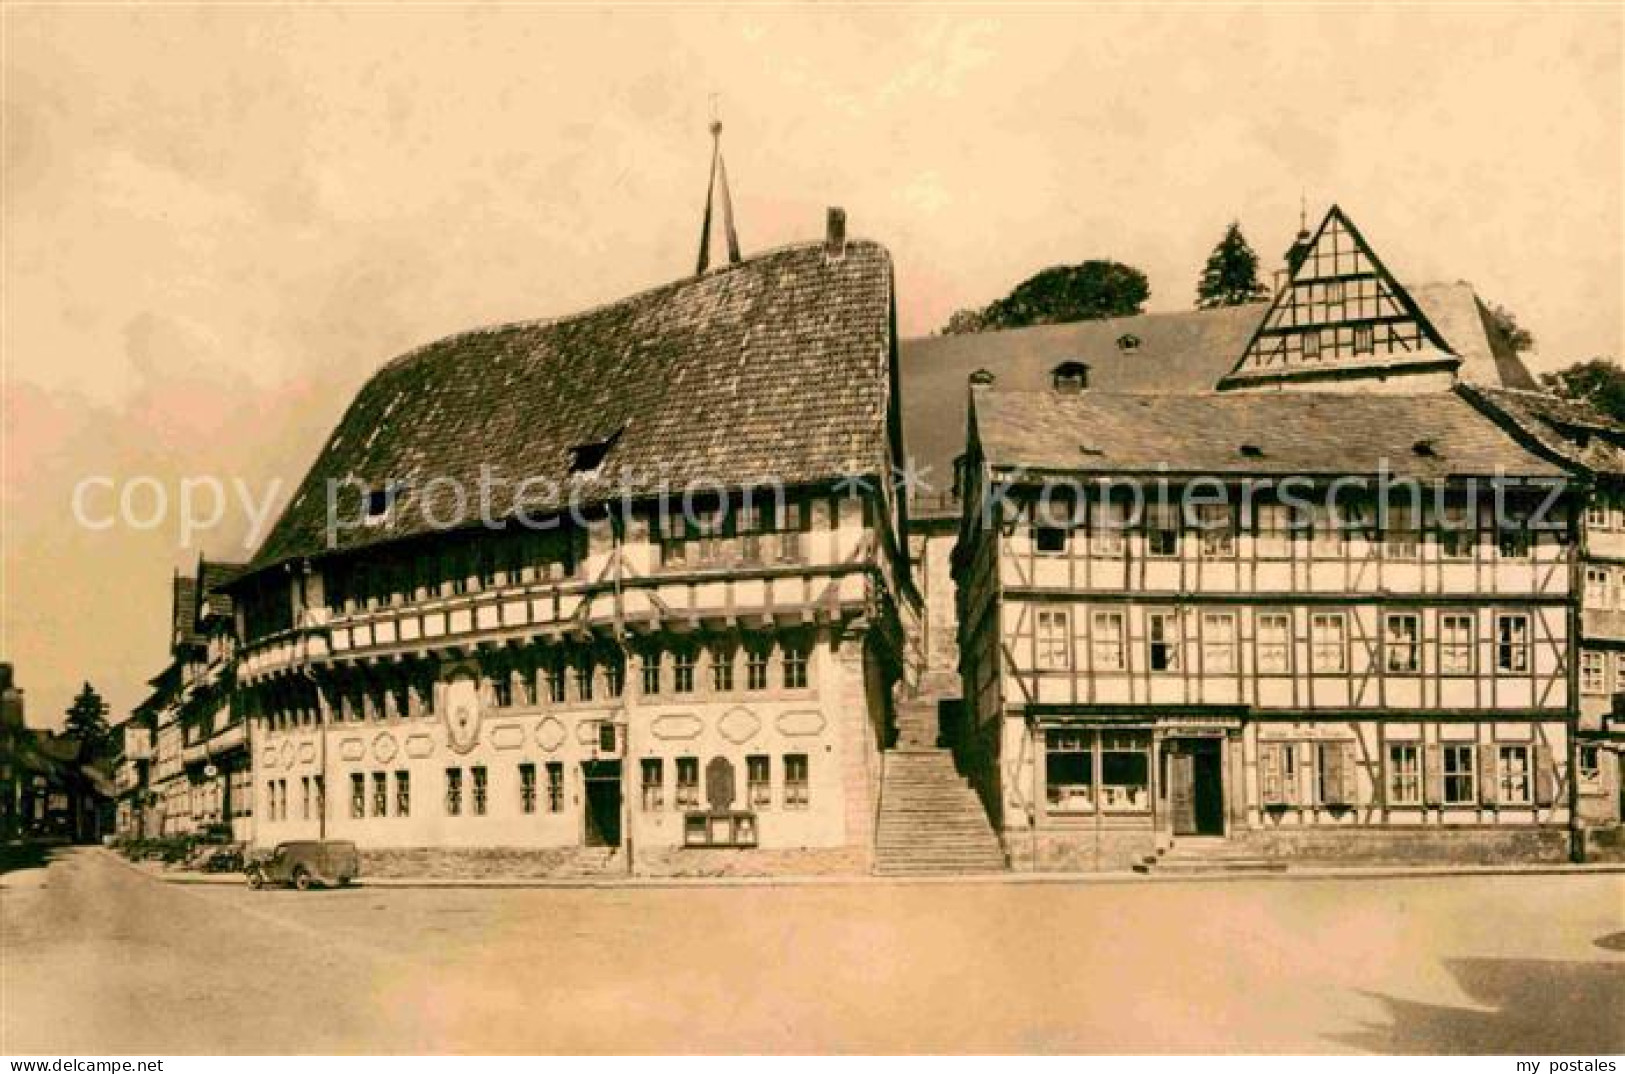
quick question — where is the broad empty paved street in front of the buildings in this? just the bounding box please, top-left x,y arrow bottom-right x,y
0,850 -> 1625,1055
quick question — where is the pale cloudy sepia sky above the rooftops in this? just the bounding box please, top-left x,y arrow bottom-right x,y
0,5 -> 1625,726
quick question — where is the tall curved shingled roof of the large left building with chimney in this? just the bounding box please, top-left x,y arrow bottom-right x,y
250,240 -> 892,570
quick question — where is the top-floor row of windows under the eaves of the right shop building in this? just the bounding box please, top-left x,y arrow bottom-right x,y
1032,502 -> 1558,562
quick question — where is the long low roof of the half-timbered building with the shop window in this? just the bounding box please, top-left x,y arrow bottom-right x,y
973,388 -> 1565,479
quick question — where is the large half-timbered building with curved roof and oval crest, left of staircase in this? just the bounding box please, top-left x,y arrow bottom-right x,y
232,206 -> 918,873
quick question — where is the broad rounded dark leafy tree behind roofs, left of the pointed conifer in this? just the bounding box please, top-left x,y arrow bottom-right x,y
943,262 -> 1151,335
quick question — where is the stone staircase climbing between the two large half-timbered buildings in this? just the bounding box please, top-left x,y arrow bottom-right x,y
874,695 -> 1006,876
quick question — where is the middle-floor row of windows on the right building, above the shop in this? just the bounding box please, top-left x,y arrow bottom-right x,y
1034,608 -> 1529,676
